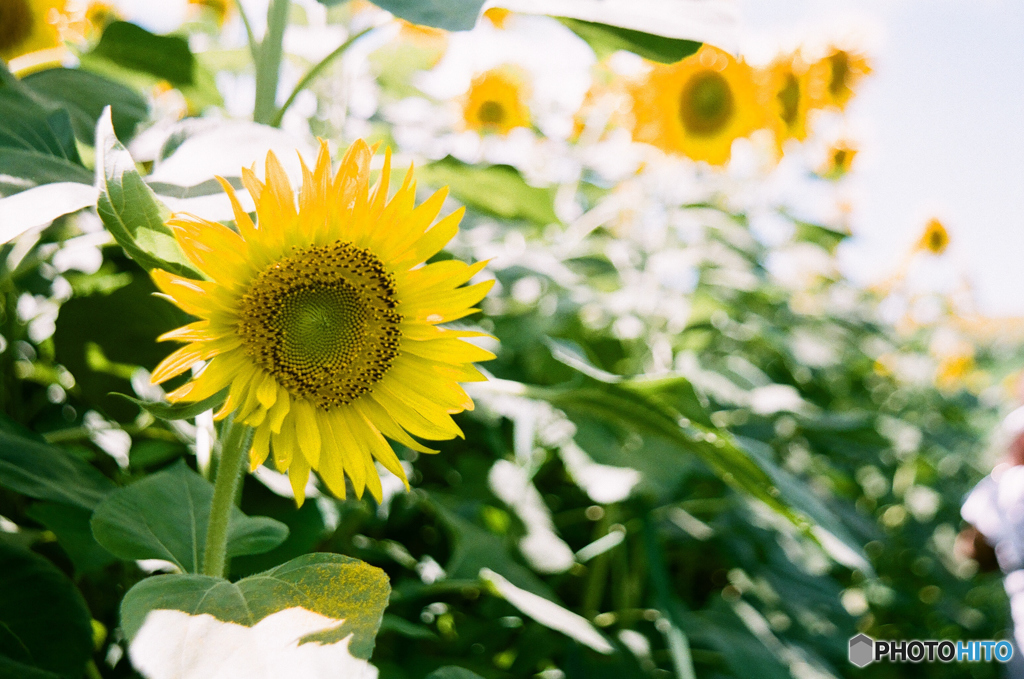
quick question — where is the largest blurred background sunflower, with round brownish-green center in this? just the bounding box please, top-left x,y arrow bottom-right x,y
632,45 -> 764,165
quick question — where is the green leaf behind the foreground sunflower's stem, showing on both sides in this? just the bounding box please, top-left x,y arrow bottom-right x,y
92,461 -> 288,572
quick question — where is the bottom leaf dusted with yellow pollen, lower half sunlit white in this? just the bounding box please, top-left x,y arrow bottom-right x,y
121,553 -> 391,663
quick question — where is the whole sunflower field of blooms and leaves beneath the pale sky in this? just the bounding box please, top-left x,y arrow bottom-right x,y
0,0 -> 1024,679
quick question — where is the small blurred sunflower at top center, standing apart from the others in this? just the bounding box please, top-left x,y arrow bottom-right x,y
462,66 -> 529,134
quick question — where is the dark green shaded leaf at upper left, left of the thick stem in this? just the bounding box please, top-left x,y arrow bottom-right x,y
87,22 -> 196,86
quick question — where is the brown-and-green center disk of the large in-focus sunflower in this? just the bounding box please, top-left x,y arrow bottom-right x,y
239,242 -> 401,408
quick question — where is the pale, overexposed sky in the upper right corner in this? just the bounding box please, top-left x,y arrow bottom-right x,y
739,0 -> 1024,315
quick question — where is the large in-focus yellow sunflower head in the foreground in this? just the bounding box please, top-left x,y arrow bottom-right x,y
153,140 -> 494,504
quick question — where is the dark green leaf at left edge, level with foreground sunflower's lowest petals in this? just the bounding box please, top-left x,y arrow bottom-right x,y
0,431 -> 116,511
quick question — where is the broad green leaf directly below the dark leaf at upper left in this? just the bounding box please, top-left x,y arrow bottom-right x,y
22,69 -> 150,145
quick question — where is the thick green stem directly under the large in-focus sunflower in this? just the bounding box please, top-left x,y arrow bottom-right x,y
203,420 -> 253,578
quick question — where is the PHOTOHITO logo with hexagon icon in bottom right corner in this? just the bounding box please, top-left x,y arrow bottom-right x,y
850,634 -> 1014,667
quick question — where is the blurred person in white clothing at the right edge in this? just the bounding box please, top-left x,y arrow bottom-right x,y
956,407 -> 1024,679
